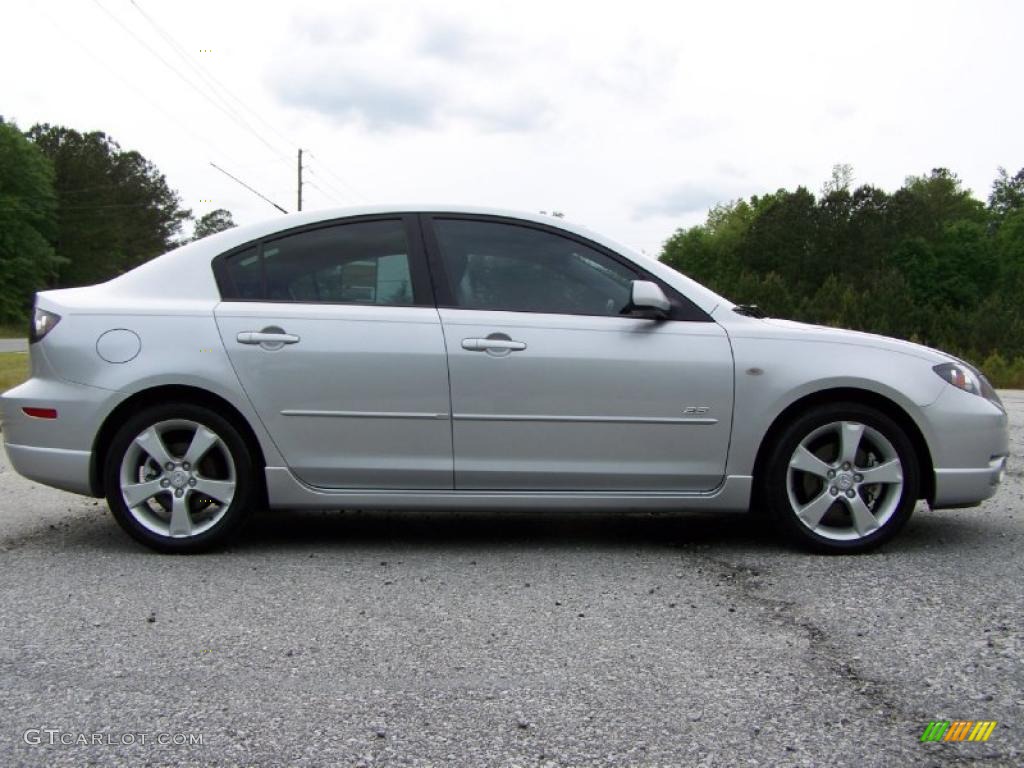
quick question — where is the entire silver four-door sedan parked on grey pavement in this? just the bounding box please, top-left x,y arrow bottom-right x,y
2,208 -> 1008,552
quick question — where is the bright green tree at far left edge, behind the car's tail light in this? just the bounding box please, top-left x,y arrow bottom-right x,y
0,118 -> 60,323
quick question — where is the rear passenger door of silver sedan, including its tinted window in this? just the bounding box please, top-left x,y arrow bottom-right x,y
216,216 -> 453,488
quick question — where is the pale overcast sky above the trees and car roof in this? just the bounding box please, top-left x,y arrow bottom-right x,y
0,0 -> 1024,255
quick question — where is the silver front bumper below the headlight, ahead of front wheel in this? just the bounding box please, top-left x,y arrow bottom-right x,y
924,386 -> 1010,509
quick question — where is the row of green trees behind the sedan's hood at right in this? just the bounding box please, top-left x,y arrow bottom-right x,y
662,166 -> 1024,385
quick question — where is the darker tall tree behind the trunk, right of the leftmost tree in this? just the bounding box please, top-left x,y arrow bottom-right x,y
29,124 -> 189,287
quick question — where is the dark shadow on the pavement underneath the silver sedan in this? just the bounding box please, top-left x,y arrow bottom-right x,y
9,501 -> 1005,557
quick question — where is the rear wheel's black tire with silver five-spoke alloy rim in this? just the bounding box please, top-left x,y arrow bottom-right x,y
103,402 -> 261,554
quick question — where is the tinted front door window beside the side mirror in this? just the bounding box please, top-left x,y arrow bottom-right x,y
434,218 -> 637,315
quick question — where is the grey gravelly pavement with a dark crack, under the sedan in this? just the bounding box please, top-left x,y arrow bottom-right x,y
0,392 -> 1024,768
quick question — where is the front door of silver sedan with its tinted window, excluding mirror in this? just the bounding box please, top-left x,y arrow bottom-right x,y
423,214 -> 733,492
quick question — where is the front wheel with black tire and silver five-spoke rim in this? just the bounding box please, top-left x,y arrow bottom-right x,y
759,402 -> 921,554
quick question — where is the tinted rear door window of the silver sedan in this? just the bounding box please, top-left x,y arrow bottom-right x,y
225,220 -> 414,305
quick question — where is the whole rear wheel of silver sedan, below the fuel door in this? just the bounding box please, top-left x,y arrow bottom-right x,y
104,402 -> 256,553
